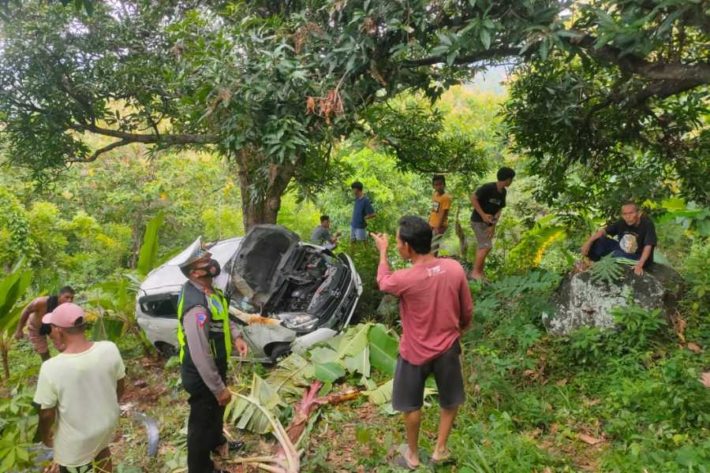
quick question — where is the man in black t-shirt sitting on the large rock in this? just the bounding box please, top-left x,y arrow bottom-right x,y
581,202 -> 657,276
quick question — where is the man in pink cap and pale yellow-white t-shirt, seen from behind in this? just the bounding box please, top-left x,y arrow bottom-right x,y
34,302 -> 126,473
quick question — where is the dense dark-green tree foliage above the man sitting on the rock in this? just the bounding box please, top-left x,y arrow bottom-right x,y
505,0 -> 710,212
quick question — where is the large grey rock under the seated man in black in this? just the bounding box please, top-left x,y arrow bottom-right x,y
542,264 -> 682,335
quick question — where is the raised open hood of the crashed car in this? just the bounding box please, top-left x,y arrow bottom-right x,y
231,225 -> 300,305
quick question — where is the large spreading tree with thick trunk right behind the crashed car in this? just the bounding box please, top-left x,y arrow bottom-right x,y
0,0 -> 710,226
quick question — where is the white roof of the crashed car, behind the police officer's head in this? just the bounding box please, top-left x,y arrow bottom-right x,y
140,237 -> 242,295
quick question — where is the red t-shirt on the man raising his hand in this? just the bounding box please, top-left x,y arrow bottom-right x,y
377,258 -> 473,365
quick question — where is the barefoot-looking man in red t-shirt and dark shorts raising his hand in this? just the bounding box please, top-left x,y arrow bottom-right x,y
371,216 -> 473,469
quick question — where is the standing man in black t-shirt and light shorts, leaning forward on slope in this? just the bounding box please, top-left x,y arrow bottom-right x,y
470,167 -> 515,281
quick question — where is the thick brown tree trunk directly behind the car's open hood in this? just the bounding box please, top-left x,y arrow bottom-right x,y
237,148 -> 296,231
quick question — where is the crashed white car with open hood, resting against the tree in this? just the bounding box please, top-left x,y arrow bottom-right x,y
136,225 -> 362,362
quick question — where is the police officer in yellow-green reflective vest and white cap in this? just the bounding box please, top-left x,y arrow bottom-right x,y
177,238 -> 248,473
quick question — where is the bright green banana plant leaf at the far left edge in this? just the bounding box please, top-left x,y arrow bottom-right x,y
0,262 -> 32,379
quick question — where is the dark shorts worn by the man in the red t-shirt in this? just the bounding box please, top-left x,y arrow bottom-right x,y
392,340 -> 466,412
